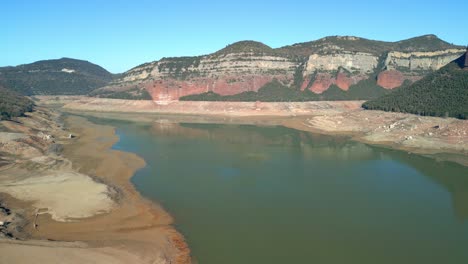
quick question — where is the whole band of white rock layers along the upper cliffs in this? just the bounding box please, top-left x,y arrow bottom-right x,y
114,49 -> 464,84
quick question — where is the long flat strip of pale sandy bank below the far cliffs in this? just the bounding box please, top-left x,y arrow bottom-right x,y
49,97 -> 362,116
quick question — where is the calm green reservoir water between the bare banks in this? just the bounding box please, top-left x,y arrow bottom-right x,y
105,122 -> 468,264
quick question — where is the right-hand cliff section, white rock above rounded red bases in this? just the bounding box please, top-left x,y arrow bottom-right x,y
302,49 -> 463,93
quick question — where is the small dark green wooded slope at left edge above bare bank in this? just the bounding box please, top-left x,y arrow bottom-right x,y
0,86 -> 34,120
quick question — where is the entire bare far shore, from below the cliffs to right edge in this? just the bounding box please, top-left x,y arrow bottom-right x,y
54,97 -> 468,166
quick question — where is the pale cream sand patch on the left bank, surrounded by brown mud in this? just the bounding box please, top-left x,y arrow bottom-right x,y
0,171 -> 115,221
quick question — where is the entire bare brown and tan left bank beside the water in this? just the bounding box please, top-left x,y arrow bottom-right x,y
0,109 -> 190,264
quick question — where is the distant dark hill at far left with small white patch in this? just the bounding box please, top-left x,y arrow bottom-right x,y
0,58 -> 113,95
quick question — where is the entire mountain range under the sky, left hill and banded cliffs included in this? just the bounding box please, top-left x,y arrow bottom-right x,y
0,35 -> 464,101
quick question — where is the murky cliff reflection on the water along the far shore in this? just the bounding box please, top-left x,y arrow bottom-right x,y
149,122 -> 468,221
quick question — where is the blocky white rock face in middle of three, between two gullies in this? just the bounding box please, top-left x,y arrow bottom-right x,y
304,51 -> 379,76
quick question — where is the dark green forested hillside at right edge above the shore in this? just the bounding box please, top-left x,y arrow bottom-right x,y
363,53 -> 468,119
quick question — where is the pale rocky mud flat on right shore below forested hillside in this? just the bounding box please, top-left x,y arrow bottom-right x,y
285,109 -> 468,160
